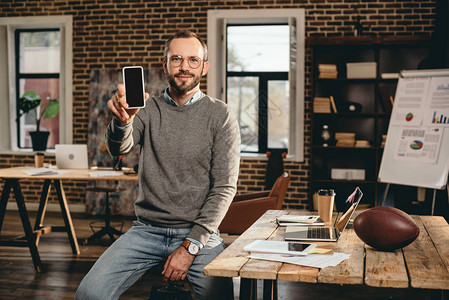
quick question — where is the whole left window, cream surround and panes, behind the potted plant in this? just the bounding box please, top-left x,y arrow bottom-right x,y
0,16 -> 73,152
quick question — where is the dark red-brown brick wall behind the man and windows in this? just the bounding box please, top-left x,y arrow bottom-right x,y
0,0 -> 436,208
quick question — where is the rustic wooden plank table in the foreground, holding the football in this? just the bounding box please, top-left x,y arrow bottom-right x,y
203,210 -> 449,299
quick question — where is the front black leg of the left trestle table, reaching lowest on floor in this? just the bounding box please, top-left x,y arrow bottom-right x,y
10,179 -> 42,272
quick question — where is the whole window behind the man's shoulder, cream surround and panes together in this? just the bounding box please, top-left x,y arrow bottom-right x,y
207,9 -> 305,161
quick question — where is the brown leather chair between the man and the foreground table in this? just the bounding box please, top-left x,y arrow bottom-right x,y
218,172 -> 290,234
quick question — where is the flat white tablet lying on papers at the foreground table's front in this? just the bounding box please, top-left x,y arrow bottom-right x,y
243,240 -> 316,256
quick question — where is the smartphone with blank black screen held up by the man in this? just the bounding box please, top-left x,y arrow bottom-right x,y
123,66 -> 145,108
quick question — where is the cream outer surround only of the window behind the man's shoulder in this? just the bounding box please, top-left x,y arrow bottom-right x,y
207,9 -> 305,162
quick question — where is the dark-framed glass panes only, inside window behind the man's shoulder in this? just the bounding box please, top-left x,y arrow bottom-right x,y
225,25 -> 289,153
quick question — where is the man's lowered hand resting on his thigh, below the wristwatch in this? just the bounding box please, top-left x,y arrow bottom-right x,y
162,246 -> 195,282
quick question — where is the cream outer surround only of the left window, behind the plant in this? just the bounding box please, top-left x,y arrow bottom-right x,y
0,15 -> 73,154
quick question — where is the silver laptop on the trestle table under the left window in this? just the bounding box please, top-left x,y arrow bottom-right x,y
55,144 -> 89,169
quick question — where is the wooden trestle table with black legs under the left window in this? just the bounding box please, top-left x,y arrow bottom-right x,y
0,167 -> 137,272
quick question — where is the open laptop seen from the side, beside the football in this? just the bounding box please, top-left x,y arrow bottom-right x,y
285,187 -> 363,242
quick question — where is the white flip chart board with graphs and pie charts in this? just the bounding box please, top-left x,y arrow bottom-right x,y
378,69 -> 449,189
